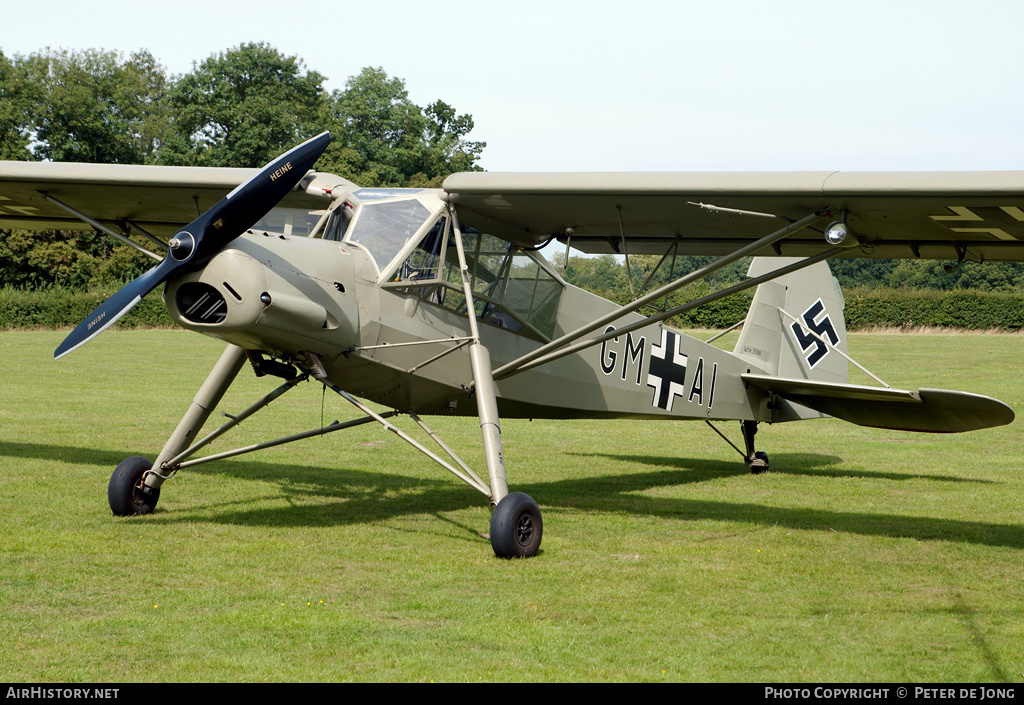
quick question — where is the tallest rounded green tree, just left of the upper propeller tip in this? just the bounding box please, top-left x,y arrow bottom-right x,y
159,43 -> 327,167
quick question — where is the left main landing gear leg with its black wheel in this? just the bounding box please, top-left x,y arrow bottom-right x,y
106,345 -> 246,516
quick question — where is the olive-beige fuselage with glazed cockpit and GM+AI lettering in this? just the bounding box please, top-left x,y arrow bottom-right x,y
165,184 -> 770,420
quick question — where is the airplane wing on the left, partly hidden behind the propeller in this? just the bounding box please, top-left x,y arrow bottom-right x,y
0,162 -> 351,236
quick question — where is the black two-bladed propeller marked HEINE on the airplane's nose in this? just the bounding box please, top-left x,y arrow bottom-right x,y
53,132 -> 331,360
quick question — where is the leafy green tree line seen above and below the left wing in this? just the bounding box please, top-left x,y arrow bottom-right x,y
0,43 -> 491,288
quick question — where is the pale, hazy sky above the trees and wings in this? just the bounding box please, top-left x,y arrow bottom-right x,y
0,0 -> 1024,171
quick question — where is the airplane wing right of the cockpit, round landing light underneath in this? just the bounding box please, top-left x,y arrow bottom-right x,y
444,171 -> 1024,261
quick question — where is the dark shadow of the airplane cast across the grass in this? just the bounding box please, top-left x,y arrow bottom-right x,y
0,442 -> 1024,548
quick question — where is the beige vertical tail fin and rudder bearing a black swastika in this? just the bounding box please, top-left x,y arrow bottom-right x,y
733,257 -> 849,382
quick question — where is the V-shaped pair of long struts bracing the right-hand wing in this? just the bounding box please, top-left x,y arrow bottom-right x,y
491,211 -> 845,380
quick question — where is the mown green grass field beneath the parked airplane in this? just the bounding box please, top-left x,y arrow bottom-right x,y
0,330 -> 1024,682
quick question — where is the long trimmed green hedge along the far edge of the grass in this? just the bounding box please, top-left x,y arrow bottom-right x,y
0,288 -> 1024,330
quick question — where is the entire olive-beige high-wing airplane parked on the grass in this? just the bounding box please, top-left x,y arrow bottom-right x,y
0,133 -> 1024,557
